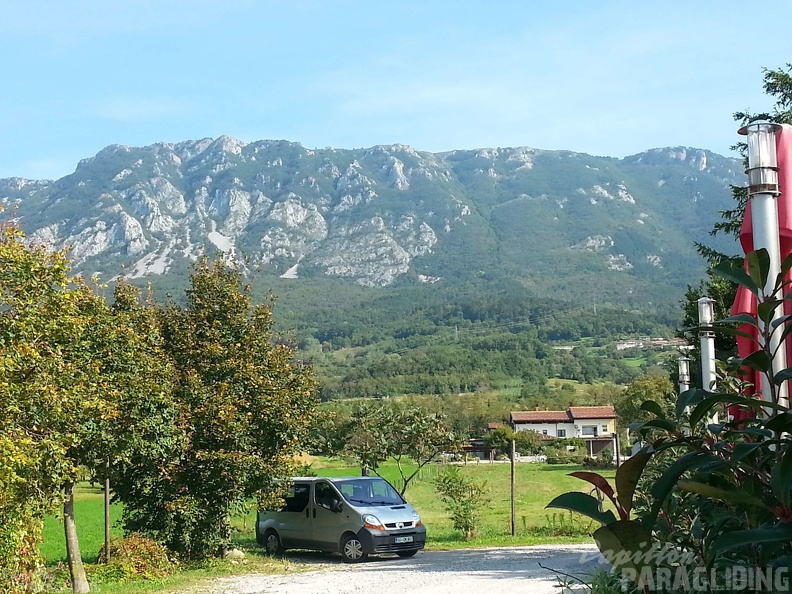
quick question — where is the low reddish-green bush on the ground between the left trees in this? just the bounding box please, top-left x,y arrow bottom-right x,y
96,534 -> 173,581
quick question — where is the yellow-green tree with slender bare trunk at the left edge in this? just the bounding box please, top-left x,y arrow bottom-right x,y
0,224 -> 174,592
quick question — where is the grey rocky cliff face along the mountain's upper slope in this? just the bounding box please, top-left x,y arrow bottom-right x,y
0,136 -> 742,298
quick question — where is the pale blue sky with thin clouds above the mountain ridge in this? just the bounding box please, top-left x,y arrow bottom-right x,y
0,0 -> 792,178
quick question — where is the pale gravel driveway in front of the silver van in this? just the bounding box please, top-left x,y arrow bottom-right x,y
201,545 -> 599,594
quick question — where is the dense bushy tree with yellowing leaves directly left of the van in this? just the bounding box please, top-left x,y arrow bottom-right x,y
116,260 -> 316,558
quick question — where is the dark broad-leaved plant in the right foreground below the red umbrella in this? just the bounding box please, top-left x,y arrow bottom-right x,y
548,245 -> 792,587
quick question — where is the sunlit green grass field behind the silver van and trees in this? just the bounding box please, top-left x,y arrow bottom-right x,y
41,459 -> 614,564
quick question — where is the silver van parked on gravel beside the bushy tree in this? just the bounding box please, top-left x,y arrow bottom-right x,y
256,476 -> 426,563
